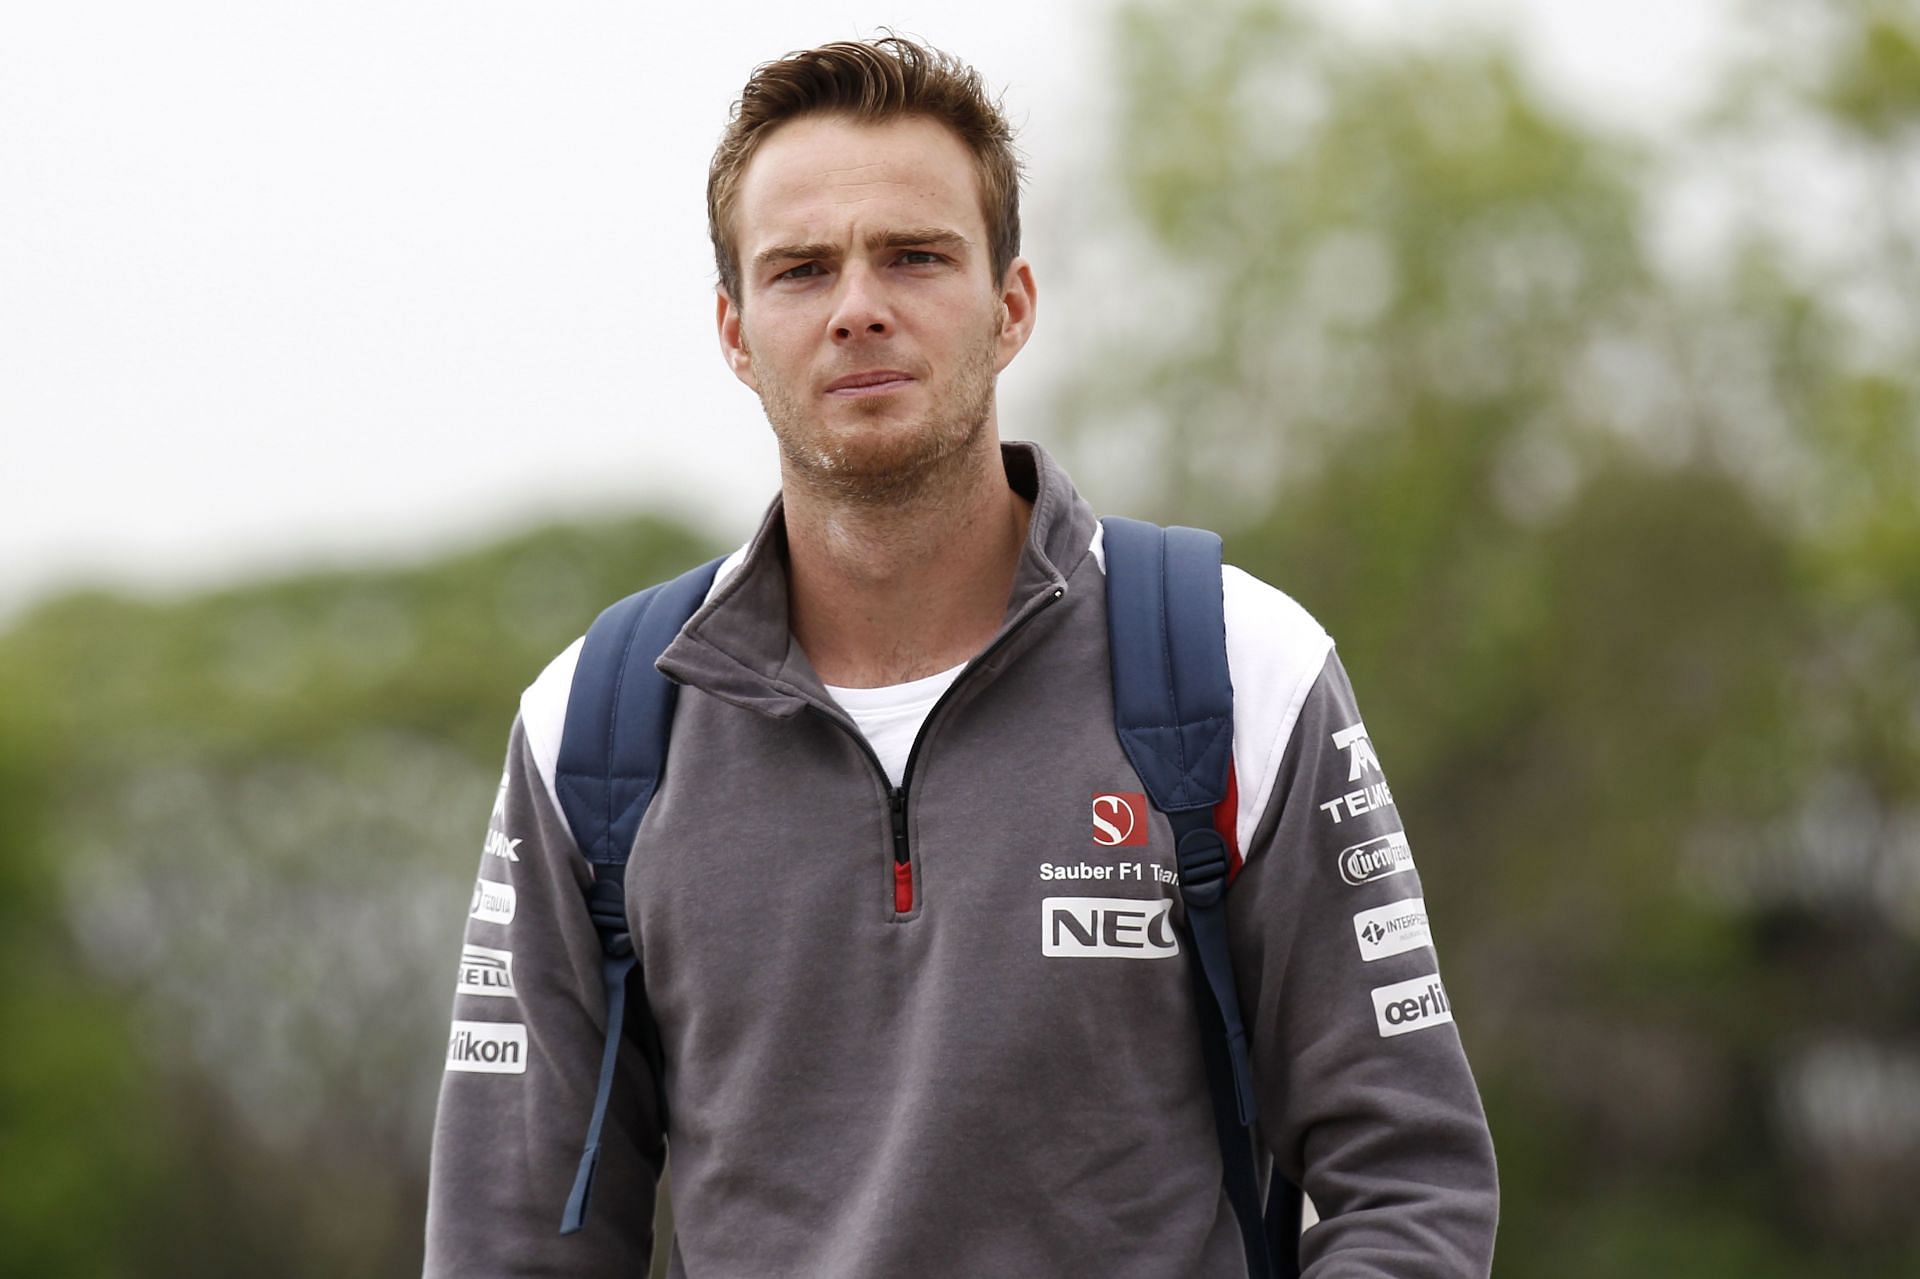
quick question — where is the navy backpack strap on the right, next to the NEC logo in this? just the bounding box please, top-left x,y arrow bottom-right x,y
1102,519 -> 1300,1279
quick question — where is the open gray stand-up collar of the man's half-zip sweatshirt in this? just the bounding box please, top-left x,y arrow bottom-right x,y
657,440 -> 1098,716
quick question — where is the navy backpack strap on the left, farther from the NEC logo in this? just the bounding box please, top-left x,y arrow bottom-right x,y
553,559 -> 720,1235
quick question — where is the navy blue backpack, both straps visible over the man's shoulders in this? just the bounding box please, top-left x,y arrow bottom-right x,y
555,519 -> 1300,1279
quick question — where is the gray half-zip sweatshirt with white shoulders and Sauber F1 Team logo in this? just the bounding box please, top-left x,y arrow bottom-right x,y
426,444 -> 1498,1279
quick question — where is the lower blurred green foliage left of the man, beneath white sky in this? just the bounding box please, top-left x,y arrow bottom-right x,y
0,519 -> 708,1279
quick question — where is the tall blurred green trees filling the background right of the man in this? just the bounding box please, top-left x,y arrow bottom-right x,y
1056,0 -> 1920,1279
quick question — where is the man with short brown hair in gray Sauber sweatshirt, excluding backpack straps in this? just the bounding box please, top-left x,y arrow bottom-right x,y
426,38 -> 1498,1279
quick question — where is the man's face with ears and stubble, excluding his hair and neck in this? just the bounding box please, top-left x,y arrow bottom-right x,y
718,115 -> 1033,501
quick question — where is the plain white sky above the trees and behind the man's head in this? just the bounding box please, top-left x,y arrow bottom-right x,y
0,0 -> 1726,618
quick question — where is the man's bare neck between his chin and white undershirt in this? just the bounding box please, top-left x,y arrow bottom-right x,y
783,426 -> 1033,688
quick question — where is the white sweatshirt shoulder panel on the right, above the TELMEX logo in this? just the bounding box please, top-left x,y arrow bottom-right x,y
1089,524 -> 1332,868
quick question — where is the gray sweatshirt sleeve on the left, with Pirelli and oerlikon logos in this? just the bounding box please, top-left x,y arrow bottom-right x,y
424,720 -> 664,1279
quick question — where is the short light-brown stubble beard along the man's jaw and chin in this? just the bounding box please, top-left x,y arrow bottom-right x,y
747,309 -> 998,507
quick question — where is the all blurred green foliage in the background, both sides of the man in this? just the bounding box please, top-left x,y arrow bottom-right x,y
0,0 -> 1920,1279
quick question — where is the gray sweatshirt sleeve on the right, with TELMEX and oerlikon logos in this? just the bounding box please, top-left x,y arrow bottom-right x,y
1227,651 -> 1500,1279
